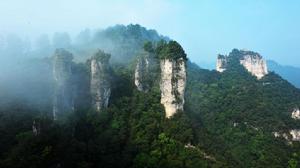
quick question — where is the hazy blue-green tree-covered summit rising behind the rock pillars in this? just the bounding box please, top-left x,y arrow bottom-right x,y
74,24 -> 169,64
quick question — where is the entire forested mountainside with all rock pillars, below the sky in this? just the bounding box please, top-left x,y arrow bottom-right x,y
0,25 -> 300,168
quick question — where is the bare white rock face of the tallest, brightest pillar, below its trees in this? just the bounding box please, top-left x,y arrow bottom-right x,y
160,59 -> 186,118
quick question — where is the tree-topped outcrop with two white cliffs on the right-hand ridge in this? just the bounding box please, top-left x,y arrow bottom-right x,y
216,49 -> 268,79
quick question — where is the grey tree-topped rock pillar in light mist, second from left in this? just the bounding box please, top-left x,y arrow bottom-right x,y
90,50 -> 111,111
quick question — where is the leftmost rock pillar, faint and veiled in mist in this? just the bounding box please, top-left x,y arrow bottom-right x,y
53,49 -> 74,119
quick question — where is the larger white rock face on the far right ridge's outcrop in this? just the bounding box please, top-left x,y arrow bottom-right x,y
240,55 -> 268,79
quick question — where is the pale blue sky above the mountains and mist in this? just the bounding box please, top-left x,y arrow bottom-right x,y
0,0 -> 300,67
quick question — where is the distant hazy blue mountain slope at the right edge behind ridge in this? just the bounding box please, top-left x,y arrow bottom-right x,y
267,60 -> 300,88
